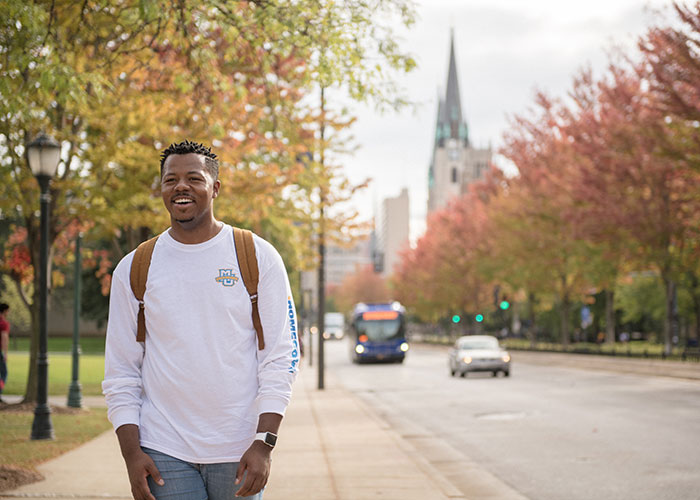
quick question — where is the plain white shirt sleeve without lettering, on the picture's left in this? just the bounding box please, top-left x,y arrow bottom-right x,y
102,252 -> 144,430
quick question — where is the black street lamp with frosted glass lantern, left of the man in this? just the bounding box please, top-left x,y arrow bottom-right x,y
27,133 -> 61,439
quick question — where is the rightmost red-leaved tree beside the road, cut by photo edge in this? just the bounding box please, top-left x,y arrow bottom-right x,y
577,64 -> 700,354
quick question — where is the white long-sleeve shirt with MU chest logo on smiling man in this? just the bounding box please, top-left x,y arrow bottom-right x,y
102,225 -> 299,463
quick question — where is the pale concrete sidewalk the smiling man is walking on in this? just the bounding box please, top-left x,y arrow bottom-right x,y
0,367 -> 518,500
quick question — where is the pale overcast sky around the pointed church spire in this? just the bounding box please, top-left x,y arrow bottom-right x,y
343,0 -> 670,241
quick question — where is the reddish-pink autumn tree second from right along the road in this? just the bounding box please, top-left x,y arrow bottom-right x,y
491,94 -> 609,346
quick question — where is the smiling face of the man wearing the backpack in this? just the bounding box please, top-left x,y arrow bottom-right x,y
160,153 -> 220,229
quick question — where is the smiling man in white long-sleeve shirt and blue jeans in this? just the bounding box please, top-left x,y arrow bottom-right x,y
102,141 -> 299,500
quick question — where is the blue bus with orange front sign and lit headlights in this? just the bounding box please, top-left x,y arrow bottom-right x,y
350,302 -> 408,363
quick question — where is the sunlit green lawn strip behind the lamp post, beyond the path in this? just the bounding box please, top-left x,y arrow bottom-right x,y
0,351 -> 105,396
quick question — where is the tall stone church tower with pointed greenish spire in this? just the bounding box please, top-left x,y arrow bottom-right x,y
428,33 -> 491,214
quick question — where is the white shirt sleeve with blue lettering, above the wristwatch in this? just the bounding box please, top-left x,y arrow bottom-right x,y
255,237 -> 300,415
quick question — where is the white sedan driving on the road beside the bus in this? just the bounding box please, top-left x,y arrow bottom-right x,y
448,335 -> 510,377
